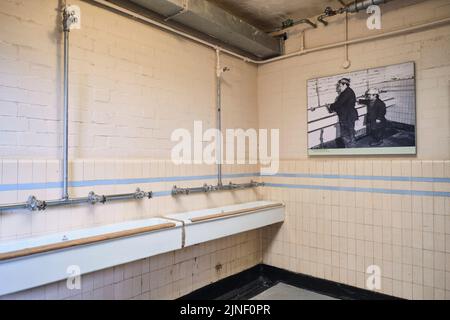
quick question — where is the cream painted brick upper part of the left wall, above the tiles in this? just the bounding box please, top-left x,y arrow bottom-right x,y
0,0 -> 257,159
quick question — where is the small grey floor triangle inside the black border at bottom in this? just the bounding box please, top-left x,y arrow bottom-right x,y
250,282 -> 337,300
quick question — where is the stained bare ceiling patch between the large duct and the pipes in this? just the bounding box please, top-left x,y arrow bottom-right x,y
208,0 -> 342,31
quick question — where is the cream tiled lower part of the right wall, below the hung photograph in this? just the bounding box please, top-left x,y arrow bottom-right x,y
263,160 -> 450,299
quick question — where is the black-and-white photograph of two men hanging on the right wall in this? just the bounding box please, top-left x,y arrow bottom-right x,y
307,62 -> 416,155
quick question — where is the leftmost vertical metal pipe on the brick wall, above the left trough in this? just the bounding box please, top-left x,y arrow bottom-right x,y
62,16 -> 70,199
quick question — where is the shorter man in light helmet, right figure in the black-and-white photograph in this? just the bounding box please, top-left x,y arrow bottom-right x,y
358,89 -> 387,147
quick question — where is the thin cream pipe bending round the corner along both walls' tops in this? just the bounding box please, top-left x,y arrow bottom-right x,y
84,0 -> 450,65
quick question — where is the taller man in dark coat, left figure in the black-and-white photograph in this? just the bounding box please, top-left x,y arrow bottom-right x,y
327,78 -> 358,148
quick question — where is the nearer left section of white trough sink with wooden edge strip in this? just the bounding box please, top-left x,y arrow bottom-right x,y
0,218 -> 182,295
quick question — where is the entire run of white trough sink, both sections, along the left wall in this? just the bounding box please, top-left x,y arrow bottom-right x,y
0,201 -> 284,296
